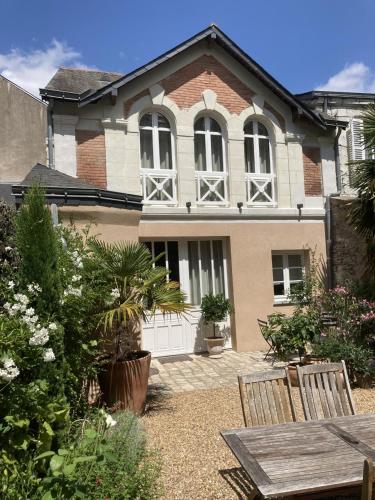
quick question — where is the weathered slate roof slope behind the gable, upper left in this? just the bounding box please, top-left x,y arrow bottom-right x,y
45,67 -> 124,94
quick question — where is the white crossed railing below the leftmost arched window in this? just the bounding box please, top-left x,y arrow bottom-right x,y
141,168 -> 177,205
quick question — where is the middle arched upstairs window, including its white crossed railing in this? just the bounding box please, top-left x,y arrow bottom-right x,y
194,116 -> 227,205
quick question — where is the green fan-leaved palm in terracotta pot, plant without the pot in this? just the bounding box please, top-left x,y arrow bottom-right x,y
90,239 -> 189,361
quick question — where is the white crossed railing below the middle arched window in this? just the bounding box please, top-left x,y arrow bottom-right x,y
195,172 -> 228,205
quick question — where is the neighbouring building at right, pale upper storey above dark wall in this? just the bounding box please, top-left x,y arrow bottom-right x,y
297,90 -> 375,284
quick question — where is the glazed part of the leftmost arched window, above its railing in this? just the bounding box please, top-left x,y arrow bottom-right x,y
139,113 -> 173,170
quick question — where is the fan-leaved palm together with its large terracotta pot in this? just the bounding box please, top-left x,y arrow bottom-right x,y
89,239 -> 189,414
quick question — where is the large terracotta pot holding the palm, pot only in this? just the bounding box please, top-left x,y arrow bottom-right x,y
99,351 -> 151,415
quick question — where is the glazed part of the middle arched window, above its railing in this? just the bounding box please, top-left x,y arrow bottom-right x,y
194,116 -> 224,172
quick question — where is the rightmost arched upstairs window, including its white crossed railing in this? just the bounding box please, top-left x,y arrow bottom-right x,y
244,121 -> 275,205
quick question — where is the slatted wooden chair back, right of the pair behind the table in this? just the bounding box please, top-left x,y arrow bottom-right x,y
297,361 -> 355,420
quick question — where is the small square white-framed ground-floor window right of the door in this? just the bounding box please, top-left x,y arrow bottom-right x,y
272,252 -> 305,302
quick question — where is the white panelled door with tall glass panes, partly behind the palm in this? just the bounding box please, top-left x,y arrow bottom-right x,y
142,240 -> 231,356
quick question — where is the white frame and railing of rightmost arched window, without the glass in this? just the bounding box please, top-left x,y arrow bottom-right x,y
244,120 -> 276,206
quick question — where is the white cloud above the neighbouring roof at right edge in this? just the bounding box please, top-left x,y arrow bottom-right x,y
316,62 -> 375,92
